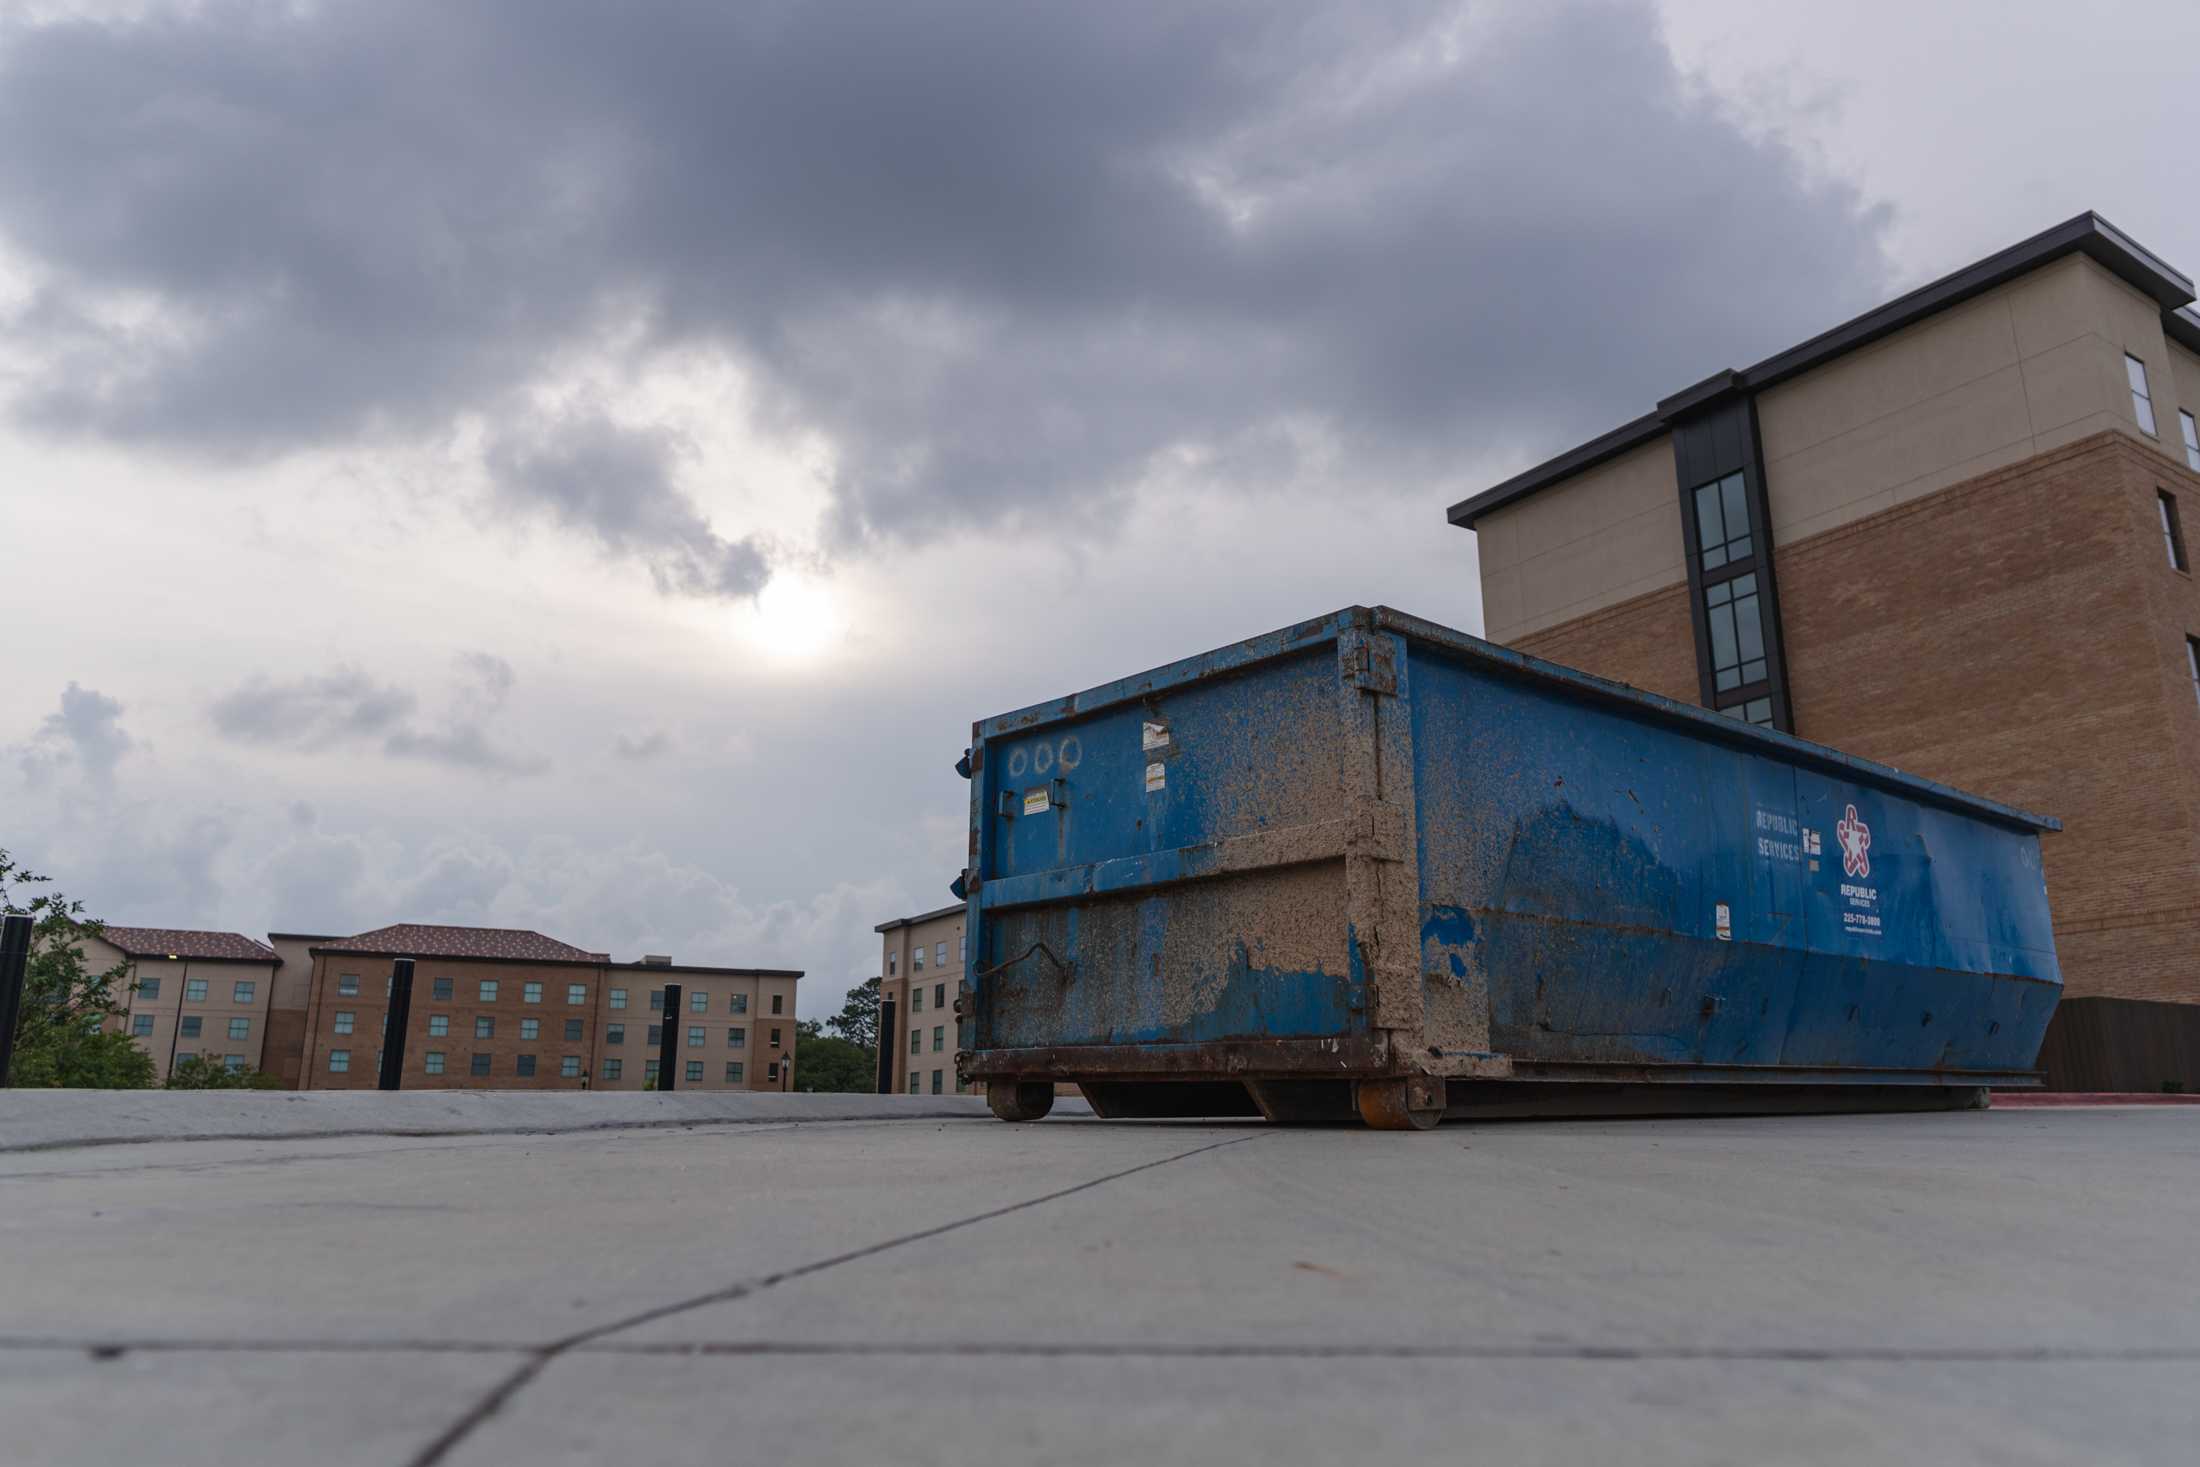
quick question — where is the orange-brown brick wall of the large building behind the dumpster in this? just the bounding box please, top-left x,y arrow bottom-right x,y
1516,433 -> 2200,1003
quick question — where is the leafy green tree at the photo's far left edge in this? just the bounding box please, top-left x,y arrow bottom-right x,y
0,849 -> 154,1091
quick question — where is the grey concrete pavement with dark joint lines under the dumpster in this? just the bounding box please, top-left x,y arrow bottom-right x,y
0,1095 -> 2200,1465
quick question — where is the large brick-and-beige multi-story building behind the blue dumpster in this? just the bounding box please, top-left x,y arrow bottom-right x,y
1450,213 -> 2200,1089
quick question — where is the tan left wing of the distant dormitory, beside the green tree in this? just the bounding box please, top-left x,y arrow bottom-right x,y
84,926 -> 282,1080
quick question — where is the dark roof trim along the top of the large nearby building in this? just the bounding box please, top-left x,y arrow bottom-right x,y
1445,209 -> 2200,530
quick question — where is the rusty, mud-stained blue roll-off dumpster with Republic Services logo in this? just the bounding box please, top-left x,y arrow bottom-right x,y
957,607 -> 2061,1128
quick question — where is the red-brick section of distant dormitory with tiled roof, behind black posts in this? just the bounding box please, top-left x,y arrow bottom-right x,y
277,924 -> 801,1091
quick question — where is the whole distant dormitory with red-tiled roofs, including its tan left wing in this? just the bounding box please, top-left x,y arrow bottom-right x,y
86,924 -> 803,1091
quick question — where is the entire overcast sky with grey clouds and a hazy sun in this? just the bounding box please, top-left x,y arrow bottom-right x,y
0,0 -> 2200,1016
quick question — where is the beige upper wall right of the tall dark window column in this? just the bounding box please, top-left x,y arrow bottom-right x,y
1758,255 -> 2196,545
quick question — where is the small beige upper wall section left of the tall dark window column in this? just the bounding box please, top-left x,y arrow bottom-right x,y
1474,435 -> 1687,642
